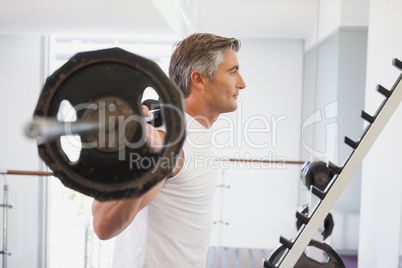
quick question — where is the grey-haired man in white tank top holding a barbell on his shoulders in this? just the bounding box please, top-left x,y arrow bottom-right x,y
92,34 -> 246,268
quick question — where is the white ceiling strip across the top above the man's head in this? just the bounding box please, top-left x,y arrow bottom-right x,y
0,0 -> 317,39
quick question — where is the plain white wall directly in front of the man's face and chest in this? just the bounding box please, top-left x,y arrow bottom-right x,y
212,39 -> 303,249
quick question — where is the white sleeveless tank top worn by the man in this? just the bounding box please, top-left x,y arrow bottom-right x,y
113,114 -> 217,268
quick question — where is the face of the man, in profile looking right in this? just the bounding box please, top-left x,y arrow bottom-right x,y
205,50 -> 246,114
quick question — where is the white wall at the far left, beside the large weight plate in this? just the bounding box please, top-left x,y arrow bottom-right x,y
0,35 -> 43,267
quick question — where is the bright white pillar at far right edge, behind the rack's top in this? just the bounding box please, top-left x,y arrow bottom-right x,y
359,0 -> 402,268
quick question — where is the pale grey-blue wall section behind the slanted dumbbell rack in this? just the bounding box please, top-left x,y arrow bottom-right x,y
300,29 -> 367,253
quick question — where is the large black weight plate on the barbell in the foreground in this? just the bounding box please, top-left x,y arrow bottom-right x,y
34,48 -> 185,200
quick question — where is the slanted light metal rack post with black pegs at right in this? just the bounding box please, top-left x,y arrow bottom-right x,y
263,59 -> 402,268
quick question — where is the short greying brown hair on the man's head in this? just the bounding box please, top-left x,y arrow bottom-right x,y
169,33 -> 241,98
